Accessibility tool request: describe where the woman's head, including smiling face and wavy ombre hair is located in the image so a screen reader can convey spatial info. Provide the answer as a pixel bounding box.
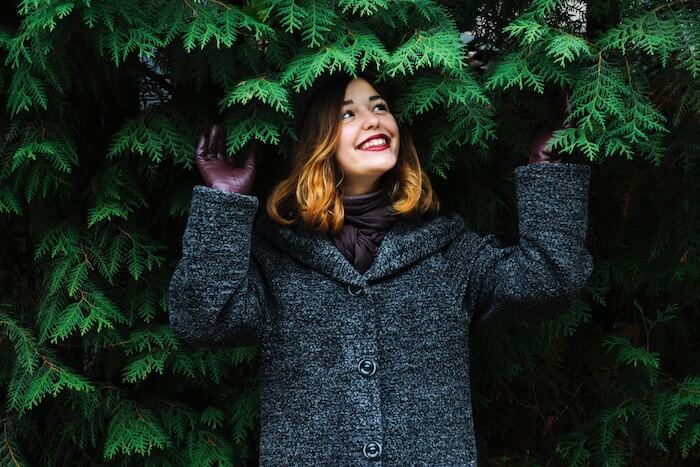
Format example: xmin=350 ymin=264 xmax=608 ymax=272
xmin=267 ymin=72 xmax=439 ymax=234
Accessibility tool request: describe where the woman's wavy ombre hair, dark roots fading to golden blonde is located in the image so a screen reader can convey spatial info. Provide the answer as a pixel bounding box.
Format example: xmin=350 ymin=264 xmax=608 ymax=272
xmin=267 ymin=73 xmax=440 ymax=234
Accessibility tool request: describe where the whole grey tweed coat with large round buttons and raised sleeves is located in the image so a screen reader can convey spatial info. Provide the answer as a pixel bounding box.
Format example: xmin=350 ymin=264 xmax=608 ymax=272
xmin=169 ymin=163 xmax=592 ymax=467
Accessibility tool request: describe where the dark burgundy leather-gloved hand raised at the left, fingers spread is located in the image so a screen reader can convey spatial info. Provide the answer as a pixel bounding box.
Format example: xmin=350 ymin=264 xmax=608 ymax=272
xmin=195 ymin=124 xmax=263 ymax=195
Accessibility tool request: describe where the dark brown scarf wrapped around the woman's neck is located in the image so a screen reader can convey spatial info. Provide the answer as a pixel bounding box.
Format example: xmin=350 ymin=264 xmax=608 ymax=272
xmin=331 ymin=188 xmax=397 ymax=274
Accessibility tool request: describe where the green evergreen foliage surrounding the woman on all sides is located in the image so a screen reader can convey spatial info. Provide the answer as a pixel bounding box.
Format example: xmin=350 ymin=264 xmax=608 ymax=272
xmin=0 ymin=0 xmax=700 ymax=466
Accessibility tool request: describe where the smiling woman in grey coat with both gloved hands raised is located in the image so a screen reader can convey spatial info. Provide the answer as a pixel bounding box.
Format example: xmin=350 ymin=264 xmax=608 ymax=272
xmin=170 ymin=71 xmax=592 ymax=466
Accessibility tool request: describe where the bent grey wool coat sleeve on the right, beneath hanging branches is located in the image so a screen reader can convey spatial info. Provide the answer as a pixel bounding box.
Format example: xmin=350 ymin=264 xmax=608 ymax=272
xmin=465 ymin=163 xmax=593 ymax=322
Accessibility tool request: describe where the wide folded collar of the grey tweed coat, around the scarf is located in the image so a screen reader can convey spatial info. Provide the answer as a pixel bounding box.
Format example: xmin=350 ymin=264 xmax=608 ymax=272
xmin=257 ymin=213 xmax=464 ymax=286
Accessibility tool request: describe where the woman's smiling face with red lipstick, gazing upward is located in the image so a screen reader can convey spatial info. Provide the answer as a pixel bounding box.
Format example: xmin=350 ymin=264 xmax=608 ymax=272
xmin=335 ymin=78 xmax=399 ymax=196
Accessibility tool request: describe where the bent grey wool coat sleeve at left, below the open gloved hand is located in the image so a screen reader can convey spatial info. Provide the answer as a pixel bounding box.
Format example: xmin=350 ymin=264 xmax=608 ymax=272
xmin=169 ymin=186 xmax=265 ymax=346
